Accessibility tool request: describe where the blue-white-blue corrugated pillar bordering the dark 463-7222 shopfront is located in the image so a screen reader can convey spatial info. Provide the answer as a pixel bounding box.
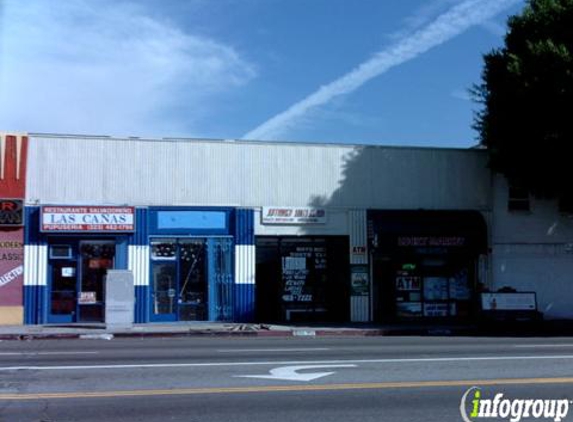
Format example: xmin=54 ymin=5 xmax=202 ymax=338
xmin=235 ymin=209 xmax=255 ymax=322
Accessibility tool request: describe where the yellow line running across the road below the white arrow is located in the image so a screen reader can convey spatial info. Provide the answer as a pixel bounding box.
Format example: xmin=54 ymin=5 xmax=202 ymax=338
xmin=0 ymin=377 xmax=573 ymax=400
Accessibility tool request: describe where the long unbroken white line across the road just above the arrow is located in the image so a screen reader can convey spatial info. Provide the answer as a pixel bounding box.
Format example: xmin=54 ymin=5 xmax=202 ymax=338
xmin=0 ymin=355 xmax=573 ymax=371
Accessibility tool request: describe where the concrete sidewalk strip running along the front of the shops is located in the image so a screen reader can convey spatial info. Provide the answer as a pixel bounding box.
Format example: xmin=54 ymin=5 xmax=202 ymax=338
xmin=0 ymin=321 xmax=573 ymax=340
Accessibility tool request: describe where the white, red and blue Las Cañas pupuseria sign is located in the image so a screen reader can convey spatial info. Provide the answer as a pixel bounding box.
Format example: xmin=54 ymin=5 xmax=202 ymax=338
xmin=41 ymin=206 xmax=135 ymax=233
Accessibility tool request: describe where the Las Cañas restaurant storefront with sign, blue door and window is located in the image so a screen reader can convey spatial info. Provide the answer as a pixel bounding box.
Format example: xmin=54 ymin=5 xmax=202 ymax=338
xmin=26 ymin=206 xmax=131 ymax=323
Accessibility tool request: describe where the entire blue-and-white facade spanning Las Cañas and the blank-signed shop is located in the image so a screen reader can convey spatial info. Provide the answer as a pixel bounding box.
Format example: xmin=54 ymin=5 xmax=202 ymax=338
xmin=24 ymin=205 xmax=255 ymax=324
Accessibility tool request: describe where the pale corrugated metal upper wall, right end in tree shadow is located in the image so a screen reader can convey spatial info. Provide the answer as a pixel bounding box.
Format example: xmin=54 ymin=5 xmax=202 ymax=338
xmin=26 ymin=136 xmax=490 ymax=209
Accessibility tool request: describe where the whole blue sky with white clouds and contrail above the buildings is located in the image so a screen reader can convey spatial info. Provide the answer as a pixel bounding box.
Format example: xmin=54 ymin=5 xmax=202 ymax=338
xmin=0 ymin=0 xmax=525 ymax=148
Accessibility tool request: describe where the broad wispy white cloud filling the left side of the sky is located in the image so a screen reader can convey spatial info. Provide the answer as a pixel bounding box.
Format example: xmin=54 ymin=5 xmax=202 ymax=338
xmin=0 ymin=0 xmax=256 ymax=136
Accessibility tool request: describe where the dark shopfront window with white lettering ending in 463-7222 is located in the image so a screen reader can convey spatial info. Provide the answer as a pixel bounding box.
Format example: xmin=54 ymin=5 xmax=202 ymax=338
xmin=256 ymin=236 xmax=350 ymax=321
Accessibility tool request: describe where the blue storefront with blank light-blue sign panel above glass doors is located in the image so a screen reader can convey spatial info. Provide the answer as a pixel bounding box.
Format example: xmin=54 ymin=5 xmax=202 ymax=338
xmin=149 ymin=208 xmax=235 ymax=321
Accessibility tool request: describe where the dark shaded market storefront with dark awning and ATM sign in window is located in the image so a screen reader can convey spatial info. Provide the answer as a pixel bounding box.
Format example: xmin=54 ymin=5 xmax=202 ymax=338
xmin=368 ymin=211 xmax=487 ymax=321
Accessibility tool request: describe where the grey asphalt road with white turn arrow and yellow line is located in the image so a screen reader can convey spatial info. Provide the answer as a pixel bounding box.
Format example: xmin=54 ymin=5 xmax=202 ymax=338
xmin=0 ymin=337 xmax=573 ymax=422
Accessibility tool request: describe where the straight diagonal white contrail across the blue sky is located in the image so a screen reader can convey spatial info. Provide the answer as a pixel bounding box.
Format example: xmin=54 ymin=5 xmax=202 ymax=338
xmin=242 ymin=0 xmax=523 ymax=139
